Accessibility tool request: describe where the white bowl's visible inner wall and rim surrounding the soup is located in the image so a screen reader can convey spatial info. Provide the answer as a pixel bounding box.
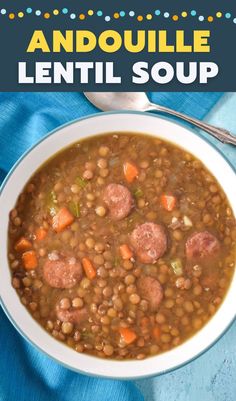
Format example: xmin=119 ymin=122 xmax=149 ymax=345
xmin=0 ymin=112 xmax=236 ymax=379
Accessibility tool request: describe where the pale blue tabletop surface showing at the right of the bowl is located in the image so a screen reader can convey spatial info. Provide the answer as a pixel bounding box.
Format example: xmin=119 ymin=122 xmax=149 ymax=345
xmin=136 ymin=94 xmax=236 ymax=401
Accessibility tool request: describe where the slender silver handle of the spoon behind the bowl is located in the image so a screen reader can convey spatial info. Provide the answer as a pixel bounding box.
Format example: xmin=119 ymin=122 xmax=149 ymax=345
xmin=148 ymin=103 xmax=236 ymax=146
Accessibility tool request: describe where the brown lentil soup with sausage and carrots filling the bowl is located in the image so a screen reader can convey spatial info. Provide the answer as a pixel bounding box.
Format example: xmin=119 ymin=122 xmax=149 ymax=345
xmin=9 ymin=133 xmax=236 ymax=359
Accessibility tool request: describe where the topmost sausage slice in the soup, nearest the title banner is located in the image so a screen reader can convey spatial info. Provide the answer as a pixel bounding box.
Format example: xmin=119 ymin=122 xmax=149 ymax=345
xmin=103 ymin=184 xmax=133 ymax=220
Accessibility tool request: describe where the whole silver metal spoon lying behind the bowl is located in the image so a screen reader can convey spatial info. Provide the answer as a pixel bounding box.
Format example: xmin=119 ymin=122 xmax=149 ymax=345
xmin=84 ymin=92 xmax=236 ymax=145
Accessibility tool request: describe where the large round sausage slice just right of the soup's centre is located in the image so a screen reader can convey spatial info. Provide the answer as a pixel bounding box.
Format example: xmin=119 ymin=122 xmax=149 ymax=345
xmin=130 ymin=223 xmax=167 ymax=263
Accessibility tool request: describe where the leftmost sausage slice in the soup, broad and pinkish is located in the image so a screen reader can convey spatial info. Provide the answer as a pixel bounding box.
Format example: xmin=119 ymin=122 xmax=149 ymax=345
xmin=43 ymin=257 xmax=83 ymax=288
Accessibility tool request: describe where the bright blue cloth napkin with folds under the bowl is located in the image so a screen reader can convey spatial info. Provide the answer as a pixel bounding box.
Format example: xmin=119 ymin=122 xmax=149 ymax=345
xmin=0 ymin=93 xmax=222 ymax=401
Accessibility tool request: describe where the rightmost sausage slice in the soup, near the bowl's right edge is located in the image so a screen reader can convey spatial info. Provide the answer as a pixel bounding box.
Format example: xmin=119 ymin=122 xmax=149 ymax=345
xmin=185 ymin=231 xmax=220 ymax=259
